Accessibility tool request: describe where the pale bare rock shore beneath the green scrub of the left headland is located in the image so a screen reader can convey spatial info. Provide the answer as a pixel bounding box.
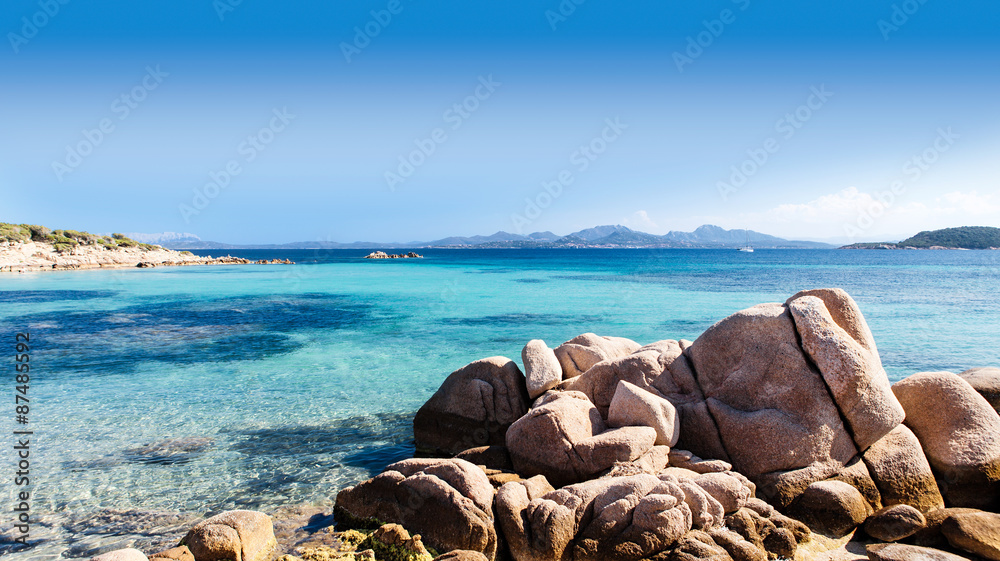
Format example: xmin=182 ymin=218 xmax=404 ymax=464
xmin=0 ymin=241 xmax=294 ymax=273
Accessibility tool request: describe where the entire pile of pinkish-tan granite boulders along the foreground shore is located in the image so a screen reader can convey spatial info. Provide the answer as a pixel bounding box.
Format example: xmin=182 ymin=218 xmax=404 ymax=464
xmin=78 ymin=289 xmax=1000 ymax=561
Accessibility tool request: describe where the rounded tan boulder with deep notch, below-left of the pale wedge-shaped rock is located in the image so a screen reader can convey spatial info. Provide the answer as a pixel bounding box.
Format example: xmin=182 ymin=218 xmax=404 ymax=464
xmin=507 ymin=391 xmax=656 ymax=486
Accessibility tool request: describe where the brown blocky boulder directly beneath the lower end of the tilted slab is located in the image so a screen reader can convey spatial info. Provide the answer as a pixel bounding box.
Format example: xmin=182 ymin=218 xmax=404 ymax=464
xmin=861 ymin=425 xmax=944 ymax=513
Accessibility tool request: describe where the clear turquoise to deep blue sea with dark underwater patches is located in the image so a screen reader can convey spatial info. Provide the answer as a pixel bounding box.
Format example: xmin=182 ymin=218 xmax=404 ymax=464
xmin=0 ymin=249 xmax=1000 ymax=559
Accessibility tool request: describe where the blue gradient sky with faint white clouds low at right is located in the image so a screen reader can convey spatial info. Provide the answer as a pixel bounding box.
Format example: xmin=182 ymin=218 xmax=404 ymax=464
xmin=0 ymin=0 xmax=1000 ymax=243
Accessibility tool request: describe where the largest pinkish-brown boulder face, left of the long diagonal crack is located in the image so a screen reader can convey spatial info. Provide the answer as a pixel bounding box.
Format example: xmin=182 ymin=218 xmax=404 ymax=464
xmin=682 ymin=304 xmax=858 ymax=487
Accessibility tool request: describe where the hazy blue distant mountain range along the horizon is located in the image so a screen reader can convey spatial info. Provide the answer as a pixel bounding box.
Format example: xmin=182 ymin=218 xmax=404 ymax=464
xmin=152 ymin=224 xmax=835 ymax=249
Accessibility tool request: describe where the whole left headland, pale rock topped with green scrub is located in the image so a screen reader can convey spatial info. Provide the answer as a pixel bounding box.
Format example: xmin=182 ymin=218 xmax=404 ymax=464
xmin=0 ymin=222 xmax=292 ymax=273
